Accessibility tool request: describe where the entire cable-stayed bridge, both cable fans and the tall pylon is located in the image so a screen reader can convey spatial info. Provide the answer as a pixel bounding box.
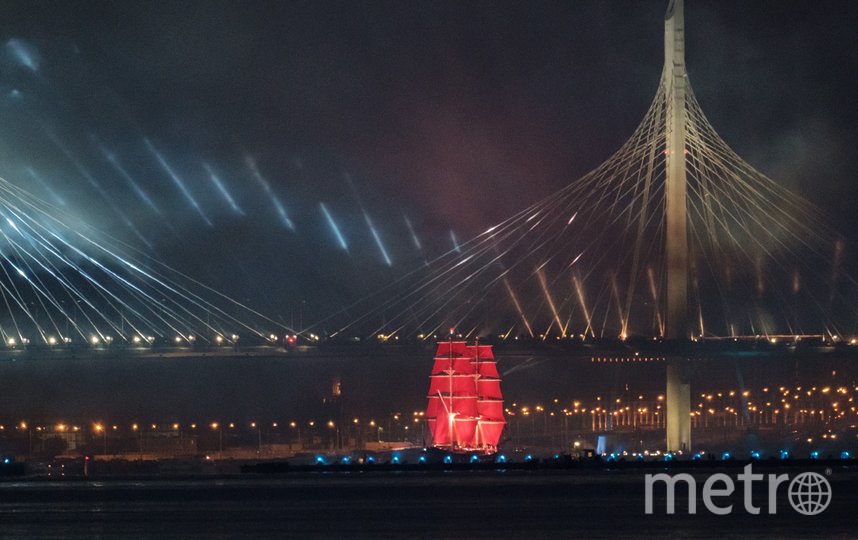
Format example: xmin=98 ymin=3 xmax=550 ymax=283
xmin=0 ymin=0 xmax=858 ymax=449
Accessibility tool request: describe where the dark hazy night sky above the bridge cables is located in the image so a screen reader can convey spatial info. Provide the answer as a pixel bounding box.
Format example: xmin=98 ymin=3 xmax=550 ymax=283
xmin=0 ymin=0 xmax=858 ymax=324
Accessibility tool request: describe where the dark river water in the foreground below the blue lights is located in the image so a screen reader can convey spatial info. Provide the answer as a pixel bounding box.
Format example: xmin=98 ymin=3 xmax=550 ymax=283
xmin=0 ymin=470 xmax=858 ymax=538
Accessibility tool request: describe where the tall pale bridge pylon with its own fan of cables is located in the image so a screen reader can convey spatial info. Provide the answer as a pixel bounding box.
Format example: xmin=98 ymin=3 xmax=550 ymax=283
xmin=316 ymin=0 xmax=858 ymax=451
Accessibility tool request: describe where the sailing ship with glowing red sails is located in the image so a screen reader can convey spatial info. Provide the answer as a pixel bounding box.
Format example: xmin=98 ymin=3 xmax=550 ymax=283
xmin=426 ymin=339 xmax=506 ymax=454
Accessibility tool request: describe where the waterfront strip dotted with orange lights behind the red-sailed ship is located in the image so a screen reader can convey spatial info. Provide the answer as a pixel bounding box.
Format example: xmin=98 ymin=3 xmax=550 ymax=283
xmin=0 ymin=378 xmax=858 ymax=460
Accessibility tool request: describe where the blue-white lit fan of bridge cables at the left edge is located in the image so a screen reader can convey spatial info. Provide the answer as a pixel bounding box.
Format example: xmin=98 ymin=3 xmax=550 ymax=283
xmin=0 ymin=173 xmax=294 ymax=348
